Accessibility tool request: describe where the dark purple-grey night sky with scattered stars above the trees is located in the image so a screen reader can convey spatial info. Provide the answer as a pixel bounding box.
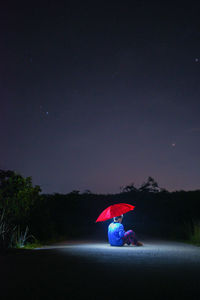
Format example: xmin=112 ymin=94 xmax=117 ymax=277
xmin=0 ymin=0 xmax=200 ymax=193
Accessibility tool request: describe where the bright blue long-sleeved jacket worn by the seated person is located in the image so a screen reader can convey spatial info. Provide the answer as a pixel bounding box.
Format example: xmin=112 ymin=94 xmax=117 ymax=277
xmin=108 ymin=222 xmax=125 ymax=246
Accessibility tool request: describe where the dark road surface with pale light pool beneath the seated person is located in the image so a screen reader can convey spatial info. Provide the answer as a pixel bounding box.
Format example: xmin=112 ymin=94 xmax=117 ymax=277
xmin=0 ymin=240 xmax=200 ymax=299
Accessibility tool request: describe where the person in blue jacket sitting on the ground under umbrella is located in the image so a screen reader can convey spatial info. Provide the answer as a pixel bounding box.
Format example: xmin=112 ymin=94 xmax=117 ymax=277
xmin=108 ymin=215 xmax=143 ymax=246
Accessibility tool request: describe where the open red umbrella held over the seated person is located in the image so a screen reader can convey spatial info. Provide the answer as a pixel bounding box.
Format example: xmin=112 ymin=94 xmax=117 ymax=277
xmin=96 ymin=203 xmax=135 ymax=223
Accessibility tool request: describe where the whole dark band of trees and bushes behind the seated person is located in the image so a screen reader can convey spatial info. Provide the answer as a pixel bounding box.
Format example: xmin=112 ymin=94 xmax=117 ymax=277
xmin=0 ymin=170 xmax=200 ymax=247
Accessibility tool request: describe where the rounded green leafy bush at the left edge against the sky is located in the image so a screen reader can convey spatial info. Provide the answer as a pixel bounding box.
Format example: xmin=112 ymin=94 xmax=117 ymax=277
xmin=0 ymin=170 xmax=41 ymax=222
